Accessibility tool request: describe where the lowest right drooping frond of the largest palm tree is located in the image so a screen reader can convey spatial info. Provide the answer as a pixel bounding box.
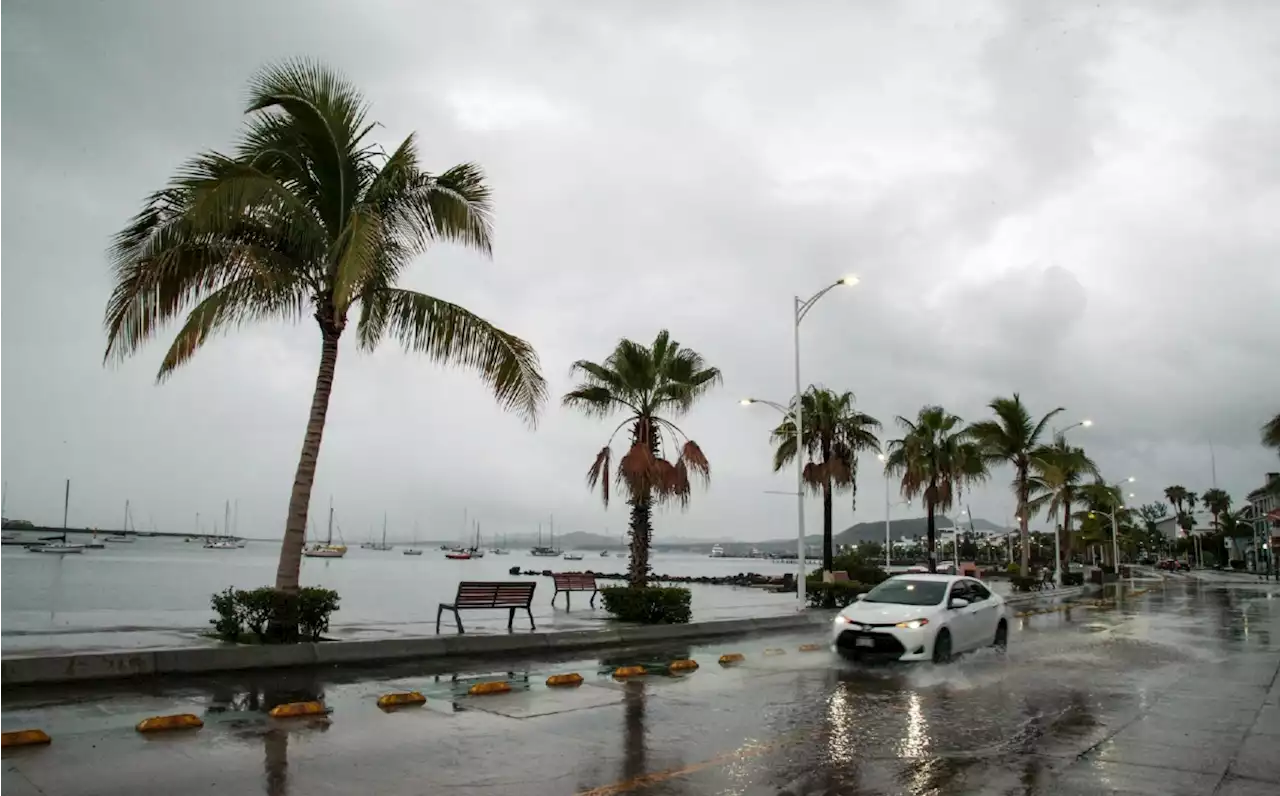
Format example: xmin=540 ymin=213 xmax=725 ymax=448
xmin=378 ymin=289 xmax=547 ymax=425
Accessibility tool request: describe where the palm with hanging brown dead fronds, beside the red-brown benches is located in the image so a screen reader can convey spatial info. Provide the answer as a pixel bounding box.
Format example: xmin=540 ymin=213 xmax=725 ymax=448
xmin=563 ymin=329 xmax=721 ymax=586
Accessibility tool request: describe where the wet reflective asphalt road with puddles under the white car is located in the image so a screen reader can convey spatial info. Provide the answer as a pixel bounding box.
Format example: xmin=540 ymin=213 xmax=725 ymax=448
xmin=0 ymin=580 xmax=1280 ymax=796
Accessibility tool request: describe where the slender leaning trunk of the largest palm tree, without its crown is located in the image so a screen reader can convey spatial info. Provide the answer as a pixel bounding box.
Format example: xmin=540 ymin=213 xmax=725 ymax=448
xmin=268 ymin=320 xmax=342 ymax=642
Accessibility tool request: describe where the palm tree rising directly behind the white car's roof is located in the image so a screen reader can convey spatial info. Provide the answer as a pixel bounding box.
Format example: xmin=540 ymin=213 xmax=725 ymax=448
xmin=884 ymin=406 xmax=987 ymax=572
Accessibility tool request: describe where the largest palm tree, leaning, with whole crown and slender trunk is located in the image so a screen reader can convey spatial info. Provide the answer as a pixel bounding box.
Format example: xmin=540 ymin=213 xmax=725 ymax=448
xmin=99 ymin=61 xmax=547 ymax=635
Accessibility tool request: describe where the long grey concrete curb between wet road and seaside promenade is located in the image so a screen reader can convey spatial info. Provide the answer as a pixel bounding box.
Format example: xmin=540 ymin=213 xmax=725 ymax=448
xmin=0 ymin=610 xmax=832 ymax=685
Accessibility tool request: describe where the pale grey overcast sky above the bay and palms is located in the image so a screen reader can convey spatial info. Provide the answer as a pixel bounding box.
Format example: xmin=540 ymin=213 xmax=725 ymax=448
xmin=0 ymin=0 xmax=1280 ymax=540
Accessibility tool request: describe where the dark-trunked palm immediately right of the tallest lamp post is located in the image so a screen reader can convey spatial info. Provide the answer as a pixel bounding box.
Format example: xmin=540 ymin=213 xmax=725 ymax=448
xmin=772 ymin=385 xmax=881 ymax=572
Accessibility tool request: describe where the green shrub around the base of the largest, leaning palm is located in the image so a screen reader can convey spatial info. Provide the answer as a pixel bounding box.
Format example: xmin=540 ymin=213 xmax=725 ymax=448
xmin=209 ymin=586 xmax=338 ymax=644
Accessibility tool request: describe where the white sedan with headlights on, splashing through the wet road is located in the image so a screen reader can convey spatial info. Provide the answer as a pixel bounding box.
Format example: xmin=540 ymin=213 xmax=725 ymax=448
xmin=831 ymin=575 xmax=1009 ymax=663
